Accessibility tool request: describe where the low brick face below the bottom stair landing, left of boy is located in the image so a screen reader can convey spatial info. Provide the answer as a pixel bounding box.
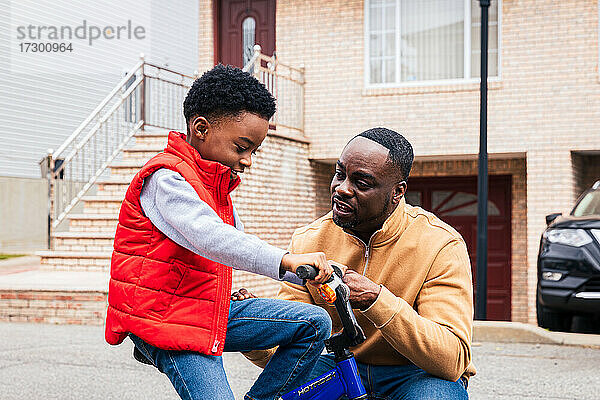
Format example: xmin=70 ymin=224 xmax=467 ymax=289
xmin=0 ymin=290 xmax=107 ymax=325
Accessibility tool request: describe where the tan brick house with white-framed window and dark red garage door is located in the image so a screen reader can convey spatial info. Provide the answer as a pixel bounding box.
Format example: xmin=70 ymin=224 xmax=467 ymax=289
xmin=199 ymin=0 xmax=600 ymax=322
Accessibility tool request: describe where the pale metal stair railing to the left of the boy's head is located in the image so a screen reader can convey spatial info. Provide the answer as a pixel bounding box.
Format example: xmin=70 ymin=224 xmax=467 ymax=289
xmin=40 ymin=55 xmax=195 ymax=248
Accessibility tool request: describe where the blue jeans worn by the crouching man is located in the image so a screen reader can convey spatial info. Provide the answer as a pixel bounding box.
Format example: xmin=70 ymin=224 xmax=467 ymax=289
xmin=312 ymin=354 xmax=469 ymax=400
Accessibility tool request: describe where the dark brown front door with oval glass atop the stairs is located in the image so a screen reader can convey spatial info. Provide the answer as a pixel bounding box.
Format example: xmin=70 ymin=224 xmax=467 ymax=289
xmin=215 ymin=0 xmax=275 ymax=67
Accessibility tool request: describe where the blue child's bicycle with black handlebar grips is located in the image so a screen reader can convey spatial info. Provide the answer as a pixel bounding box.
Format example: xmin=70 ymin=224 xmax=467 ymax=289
xmin=279 ymin=265 xmax=367 ymax=400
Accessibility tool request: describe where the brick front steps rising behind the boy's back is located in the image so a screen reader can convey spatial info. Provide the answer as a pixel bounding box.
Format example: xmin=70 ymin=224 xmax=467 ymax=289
xmin=0 ymin=130 xmax=167 ymax=325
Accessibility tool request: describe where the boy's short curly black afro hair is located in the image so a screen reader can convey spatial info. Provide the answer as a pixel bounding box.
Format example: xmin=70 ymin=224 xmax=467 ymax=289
xmin=183 ymin=64 xmax=275 ymax=122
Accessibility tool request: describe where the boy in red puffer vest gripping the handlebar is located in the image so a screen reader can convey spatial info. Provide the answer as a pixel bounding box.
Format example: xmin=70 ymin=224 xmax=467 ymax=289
xmin=106 ymin=65 xmax=333 ymax=400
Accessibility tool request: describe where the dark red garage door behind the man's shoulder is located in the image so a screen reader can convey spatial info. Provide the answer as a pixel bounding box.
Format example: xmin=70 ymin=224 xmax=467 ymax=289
xmin=406 ymin=175 xmax=511 ymax=321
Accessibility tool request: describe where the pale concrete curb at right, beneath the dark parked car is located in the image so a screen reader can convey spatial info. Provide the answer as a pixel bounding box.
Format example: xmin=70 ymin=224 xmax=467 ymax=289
xmin=473 ymin=321 xmax=600 ymax=348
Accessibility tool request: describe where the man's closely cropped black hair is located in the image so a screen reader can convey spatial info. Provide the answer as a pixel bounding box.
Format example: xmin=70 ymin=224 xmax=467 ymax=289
xmin=355 ymin=128 xmax=414 ymax=180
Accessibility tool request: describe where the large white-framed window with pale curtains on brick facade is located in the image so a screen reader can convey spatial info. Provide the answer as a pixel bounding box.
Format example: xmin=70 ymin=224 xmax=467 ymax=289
xmin=365 ymin=0 xmax=500 ymax=86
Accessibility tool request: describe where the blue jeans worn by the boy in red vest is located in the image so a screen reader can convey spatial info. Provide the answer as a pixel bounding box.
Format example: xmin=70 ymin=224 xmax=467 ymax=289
xmin=130 ymin=299 xmax=331 ymax=400
